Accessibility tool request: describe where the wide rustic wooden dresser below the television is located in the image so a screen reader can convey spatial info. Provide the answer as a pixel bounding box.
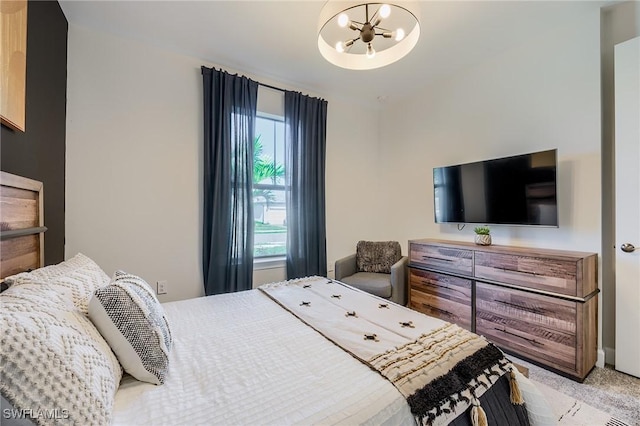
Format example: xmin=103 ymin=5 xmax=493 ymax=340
xmin=409 ymin=239 xmax=599 ymax=381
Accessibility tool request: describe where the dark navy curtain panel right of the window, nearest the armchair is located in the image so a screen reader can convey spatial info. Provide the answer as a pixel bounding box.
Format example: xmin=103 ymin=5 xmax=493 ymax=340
xmin=284 ymin=91 xmax=327 ymax=279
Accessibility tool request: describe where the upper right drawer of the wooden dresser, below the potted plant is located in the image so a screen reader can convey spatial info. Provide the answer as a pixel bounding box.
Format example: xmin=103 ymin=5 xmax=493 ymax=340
xmin=475 ymin=251 xmax=583 ymax=296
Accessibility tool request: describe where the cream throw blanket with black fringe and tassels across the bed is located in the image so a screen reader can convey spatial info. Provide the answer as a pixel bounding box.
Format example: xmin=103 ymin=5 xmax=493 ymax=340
xmin=260 ymin=277 xmax=522 ymax=425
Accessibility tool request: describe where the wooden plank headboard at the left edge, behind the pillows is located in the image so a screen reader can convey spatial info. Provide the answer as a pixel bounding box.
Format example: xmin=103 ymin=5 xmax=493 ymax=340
xmin=0 ymin=172 xmax=47 ymax=279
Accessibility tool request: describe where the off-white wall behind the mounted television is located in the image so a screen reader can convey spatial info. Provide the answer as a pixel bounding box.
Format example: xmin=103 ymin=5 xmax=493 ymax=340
xmin=381 ymin=11 xmax=601 ymax=354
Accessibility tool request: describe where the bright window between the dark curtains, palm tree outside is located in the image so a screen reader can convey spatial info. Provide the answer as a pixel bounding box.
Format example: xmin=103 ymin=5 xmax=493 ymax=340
xmin=253 ymin=115 xmax=287 ymax=258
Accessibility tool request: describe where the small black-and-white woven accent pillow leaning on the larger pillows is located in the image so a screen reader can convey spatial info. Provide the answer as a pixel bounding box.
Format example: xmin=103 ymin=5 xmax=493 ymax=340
xmin=89 ymin=271 xmax=171 ymax=385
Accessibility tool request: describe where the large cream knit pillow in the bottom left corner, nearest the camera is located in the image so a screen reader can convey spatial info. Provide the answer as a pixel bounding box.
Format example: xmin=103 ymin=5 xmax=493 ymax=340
xmin=0 ymin=282 xmax=122 ymax=425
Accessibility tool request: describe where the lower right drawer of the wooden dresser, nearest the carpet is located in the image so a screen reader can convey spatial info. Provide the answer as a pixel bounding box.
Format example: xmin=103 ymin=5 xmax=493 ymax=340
xmin=476 ymin=282 xmax=577 ymax=373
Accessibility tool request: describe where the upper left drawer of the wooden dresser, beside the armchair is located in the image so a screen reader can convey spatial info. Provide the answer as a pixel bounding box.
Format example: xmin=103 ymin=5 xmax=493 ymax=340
xmin=409 ymin=243 xmax=473 ymax=275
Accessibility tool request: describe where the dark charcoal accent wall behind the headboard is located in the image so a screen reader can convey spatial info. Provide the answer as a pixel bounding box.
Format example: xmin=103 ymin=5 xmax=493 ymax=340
xmin=0 ymin=1 xmax=68 ymax=265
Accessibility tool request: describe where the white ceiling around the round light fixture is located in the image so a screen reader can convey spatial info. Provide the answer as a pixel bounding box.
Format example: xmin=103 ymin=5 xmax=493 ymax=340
xmin=60 ymin=0 xmax=611 ymax=103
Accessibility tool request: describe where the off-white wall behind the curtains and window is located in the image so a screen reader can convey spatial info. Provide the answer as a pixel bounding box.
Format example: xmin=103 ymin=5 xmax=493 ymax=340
xmin=65 ymin=25 xmax=378 ymax=301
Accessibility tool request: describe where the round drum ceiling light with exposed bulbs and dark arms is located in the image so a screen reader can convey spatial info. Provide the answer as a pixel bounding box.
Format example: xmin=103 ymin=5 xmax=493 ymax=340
xmin=318 ymin=0 xmax=420 ymax=70
